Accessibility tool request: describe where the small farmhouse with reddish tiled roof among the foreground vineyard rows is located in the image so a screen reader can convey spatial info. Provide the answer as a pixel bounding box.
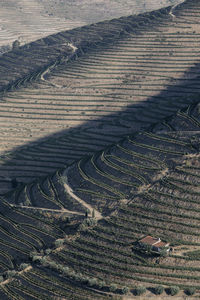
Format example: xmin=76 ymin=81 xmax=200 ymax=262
xmin=137 ymin=235 xmax=170 ymax=253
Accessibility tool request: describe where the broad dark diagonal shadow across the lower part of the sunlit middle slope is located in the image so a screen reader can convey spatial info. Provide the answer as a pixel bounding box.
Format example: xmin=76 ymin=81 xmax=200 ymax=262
xmin=0 ymin=55 xmax=200 ymax=195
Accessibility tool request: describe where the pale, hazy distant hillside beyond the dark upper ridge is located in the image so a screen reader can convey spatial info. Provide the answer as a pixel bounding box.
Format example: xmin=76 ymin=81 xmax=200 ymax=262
xmin=0 ymin=0 xmax=177 ymax=54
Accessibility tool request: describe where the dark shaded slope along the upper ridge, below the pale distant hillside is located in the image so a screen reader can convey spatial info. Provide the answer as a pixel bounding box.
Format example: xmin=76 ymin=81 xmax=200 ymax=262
xmin=0 ymin=3 xmax=171 ymax=94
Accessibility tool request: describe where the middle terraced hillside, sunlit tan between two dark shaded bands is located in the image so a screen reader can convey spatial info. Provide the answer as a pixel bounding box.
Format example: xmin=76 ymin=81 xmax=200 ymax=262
xmin=0 ymin=1 xmax=199 ymax=193
